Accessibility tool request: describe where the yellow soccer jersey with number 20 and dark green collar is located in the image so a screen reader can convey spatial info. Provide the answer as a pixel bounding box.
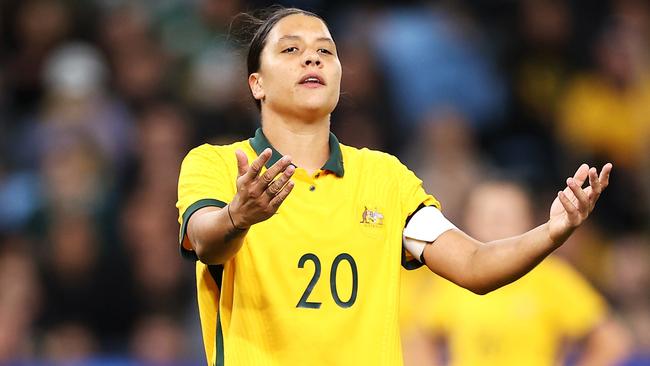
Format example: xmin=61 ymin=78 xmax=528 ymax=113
xmin=177 ymin=129 xmax=439 ymax=366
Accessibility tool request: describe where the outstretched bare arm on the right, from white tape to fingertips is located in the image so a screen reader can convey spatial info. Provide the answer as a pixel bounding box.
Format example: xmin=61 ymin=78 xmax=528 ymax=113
xmin=423 ymin=163 xmax=612 ymax=294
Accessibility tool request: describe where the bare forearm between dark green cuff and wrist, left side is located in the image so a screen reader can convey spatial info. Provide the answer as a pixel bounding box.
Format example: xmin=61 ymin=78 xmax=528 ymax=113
xmin=187 ymin=207 xmax=248 ymax=264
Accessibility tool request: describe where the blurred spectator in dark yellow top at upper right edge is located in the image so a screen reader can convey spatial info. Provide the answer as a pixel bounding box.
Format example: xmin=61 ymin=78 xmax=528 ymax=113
xmin=558 ymin=19 xmax=650 ymax=169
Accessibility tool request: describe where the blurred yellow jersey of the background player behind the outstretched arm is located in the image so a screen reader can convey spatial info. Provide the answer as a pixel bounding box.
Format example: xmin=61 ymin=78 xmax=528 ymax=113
xmin=404 ymin=256 xmax=606 ymax=366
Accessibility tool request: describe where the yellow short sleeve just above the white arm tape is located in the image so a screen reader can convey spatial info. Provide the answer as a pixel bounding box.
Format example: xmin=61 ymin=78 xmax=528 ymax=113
xmin=394 ymin=158 xmax=441 ymax=270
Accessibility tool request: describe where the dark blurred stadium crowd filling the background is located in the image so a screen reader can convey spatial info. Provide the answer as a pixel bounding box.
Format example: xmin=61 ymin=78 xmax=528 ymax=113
xmin=0 ymin=0 xmax=650 ymax=364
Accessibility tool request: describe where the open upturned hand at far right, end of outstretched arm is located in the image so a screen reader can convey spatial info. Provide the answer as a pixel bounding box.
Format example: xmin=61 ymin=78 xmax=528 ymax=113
xmin=548 ymin=163 xmax=612 ymax=244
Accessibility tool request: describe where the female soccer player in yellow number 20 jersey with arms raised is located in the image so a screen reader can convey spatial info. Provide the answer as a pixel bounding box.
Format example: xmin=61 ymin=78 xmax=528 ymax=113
xmin=177 ymin=8 xmax=612 ymax=365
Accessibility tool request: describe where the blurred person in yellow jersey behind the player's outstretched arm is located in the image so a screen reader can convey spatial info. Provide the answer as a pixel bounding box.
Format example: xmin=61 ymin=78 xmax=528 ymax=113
xmin=404 ymin=181 xmax=629 ymax=365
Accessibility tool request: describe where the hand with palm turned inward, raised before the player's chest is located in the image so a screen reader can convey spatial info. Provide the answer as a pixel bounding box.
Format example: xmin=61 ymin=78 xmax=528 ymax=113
xmin=228 ymin=148 xmax=296 ymax=229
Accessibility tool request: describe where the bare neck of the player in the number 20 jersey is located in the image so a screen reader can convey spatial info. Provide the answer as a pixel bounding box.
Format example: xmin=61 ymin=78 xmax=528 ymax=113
xmin=262 ymin=110 xmax=330 ymax=174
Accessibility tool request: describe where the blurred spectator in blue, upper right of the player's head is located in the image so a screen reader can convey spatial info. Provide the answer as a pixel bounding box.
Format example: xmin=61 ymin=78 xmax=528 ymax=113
xmin=371 ymin=2 xmax=504 ymax=139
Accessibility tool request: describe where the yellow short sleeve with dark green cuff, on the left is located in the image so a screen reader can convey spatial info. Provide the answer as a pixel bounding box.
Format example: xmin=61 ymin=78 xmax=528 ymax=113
xmin=176 ymin=144 xmax=236 ymax=260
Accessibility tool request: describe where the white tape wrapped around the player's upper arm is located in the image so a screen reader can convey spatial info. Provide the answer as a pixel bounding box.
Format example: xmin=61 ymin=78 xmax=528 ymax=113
xmin=402 ymin=206 xmax=456 ymax=261
